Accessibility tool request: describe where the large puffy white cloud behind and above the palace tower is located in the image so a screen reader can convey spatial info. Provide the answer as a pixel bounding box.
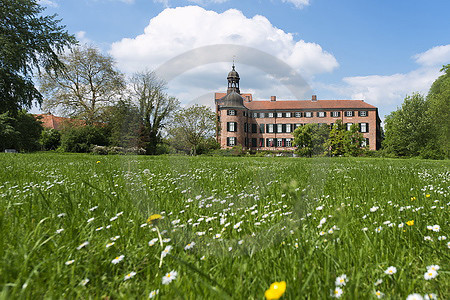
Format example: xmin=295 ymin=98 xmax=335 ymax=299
xmin=110 ymin=6 xmax=338 ymax=102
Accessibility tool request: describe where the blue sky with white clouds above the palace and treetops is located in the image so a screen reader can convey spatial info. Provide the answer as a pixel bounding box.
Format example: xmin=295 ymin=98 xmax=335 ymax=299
xmin=40 ymin=0 xmax=450 ymax=118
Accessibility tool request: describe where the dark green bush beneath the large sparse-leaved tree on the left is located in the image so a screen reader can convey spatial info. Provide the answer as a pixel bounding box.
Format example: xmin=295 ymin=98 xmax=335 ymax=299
xmin=61 ymin=125 xmax=109 ymax=153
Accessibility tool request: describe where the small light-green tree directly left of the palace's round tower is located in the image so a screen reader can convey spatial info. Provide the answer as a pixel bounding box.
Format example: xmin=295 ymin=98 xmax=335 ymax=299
xmin=169 ymin=105 xmax=216 ymax=155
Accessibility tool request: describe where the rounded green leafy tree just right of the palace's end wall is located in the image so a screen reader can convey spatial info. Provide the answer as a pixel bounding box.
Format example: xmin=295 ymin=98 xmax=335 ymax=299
xmin=383 ymin=93 xmax=435 ymax=157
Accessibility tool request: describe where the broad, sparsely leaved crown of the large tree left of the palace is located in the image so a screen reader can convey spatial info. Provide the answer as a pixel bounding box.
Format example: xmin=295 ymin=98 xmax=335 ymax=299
xmin=41 ymin=46 xmax=125 ymax=124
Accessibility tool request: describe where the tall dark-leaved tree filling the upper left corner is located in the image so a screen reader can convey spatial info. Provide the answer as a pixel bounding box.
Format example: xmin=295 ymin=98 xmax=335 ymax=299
xmin=0 ymin=0 xmax=76 ymax=115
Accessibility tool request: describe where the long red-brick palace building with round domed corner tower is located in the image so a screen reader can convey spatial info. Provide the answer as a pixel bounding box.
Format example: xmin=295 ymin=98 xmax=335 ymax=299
xmin=215 ymin=64 xmax=381 ymax=150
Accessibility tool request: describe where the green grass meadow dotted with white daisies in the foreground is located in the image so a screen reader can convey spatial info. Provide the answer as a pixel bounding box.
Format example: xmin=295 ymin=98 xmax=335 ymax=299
xmin=0 ymin=153 xmax=450 ymax=299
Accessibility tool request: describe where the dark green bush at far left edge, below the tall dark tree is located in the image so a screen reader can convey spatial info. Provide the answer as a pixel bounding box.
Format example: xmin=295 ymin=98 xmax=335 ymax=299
xmin=0 ymin=110 xmax=43 ymax=152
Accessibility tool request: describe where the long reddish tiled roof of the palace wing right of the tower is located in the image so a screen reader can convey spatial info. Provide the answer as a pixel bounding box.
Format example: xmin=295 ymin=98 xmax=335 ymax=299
xmin=245 ymin=100 xmax=376 ymax=110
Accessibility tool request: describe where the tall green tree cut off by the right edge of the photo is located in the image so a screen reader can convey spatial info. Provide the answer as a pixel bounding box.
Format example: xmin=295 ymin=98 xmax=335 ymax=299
xmin=427 ymin=64 xmax=450 ymax=158
